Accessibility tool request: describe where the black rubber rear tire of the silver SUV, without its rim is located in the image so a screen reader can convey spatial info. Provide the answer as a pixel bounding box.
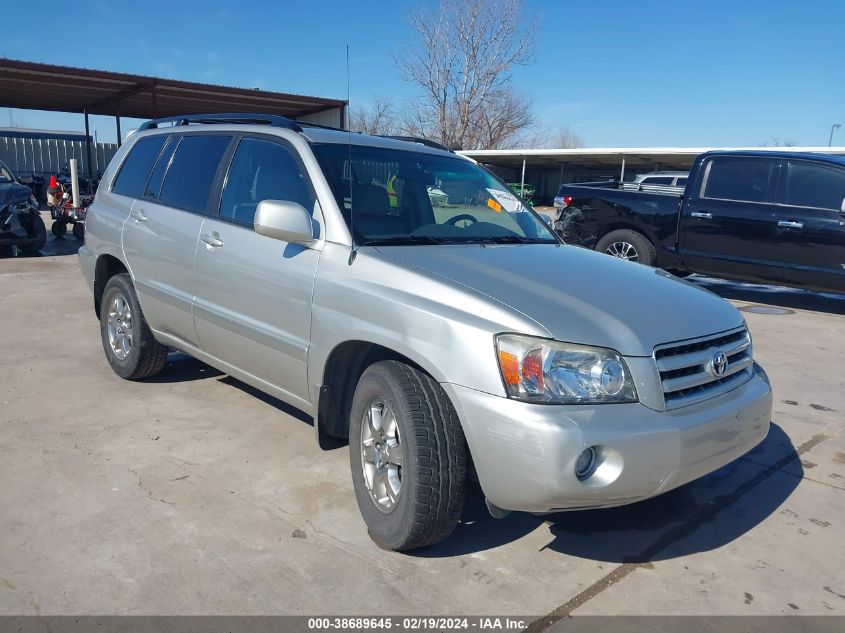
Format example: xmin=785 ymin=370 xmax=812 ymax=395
xmin=100 ymin=273 xmax=167 ymax=380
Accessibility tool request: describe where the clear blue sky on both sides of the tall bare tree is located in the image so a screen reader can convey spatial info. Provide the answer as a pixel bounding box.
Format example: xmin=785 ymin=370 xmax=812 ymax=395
xmin=0 ymin=0 xmax=845 ymax=147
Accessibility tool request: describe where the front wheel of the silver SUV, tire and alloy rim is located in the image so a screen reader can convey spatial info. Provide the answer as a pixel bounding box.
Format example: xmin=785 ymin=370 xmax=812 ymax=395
xmin=349 ymin=360 xmax=467 ymax=550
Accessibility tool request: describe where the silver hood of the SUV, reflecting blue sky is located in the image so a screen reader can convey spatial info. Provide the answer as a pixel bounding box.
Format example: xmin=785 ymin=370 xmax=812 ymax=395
xmin=378 ymin=244 xmax=743 ymax=356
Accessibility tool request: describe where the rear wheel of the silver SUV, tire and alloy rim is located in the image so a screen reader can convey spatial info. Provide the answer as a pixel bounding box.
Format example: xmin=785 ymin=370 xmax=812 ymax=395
xmin=100 ymin=273 xmax=167 ymax=380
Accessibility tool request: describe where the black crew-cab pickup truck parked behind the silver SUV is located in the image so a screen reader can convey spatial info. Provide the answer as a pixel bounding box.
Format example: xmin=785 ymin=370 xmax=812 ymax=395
xmin=555 ymin=151 xmax=845 ymax=293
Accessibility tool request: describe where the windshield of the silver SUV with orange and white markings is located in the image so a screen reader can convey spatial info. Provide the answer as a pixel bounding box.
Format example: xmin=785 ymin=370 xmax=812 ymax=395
xmin=313 ymin=143 xmax=557 ymax=245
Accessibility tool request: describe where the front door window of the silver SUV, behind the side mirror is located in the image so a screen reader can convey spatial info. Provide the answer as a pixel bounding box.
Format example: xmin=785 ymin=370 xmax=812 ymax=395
xmin=220 ymin=138 xmax=314 ymax=225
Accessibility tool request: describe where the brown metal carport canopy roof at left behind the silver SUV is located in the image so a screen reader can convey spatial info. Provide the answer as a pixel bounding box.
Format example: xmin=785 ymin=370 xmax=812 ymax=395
xmin=0 ymin=58 xmax=346 ymax=122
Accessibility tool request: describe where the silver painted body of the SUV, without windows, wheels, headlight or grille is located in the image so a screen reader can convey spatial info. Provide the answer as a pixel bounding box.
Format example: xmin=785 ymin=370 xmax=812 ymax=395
xmin=80 ymin=125 xmax=771 ymax=512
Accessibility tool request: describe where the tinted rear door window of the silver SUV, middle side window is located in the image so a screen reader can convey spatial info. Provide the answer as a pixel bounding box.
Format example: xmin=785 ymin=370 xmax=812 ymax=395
xmin=159 ymin=135 xmax=231 ymax=213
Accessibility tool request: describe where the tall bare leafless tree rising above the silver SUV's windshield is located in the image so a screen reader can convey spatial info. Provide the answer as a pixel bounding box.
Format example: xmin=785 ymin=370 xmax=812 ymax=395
xmin=395 ymin=0 xmax=535 ymax=149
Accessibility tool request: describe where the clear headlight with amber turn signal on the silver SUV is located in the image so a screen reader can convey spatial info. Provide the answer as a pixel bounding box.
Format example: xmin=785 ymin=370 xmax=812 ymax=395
xmin=496 ymin=334 xmax=637 ymax=404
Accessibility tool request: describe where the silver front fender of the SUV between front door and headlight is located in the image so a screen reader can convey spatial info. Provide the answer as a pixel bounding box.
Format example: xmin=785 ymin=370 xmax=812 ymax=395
xmin=308 ymin=243 xmax=549 ymax=402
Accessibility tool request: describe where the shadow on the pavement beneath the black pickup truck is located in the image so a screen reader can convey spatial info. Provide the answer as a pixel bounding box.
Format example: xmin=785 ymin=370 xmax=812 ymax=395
xmin=686 ymin=275 xmax=845 ymax=314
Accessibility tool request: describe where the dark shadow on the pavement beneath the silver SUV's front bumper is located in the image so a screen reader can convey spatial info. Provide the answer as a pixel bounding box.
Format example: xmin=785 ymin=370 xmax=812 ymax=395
xmin=411 ymin=424 xmax=803 ymax=563
